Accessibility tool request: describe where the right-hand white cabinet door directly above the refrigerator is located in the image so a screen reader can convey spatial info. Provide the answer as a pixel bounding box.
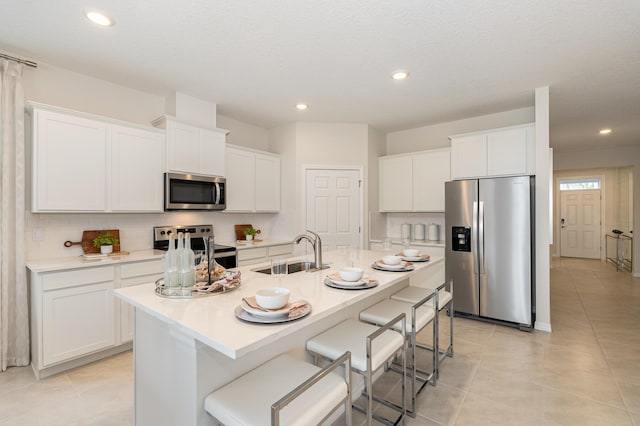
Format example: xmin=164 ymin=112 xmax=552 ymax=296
xmin=487 ymin=127 xmax=527 ymax=176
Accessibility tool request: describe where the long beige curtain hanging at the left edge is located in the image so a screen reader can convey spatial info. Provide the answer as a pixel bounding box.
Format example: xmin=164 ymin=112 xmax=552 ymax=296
xmin=0 ymin=59 xmax=29 ymax=371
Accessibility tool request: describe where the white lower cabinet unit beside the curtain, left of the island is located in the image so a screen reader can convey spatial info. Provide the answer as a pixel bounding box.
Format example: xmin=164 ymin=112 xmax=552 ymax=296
xmin=29 ymin=259 xmax=163 ymax=377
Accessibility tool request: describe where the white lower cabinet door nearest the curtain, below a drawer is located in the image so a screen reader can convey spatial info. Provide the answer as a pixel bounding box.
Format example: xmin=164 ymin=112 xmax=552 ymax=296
xmin=42 ymin=281 xmax=115 ymax=366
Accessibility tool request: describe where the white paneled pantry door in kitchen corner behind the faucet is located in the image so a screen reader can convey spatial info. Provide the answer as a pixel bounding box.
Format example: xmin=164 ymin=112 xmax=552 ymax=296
xmin=305 ymin=169 xmax=362 ymax=250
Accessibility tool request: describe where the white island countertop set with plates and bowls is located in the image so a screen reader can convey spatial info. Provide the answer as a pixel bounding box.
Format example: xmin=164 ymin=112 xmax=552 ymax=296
xmin=115 ymin=250 xmax=444 ymax=359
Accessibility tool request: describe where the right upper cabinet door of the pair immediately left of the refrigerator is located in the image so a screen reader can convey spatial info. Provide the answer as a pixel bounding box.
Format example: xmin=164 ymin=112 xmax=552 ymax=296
xmin=413 ymin=150 xmax=451 ymax=212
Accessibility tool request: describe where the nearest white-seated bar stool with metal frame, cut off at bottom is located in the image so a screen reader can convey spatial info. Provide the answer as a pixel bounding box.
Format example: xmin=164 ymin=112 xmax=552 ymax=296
xmin=204 ymin=352 xmax=351 ymax=426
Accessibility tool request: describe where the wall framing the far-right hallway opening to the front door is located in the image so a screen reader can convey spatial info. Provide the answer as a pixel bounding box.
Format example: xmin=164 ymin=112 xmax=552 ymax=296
xmin=553 ymin=145 xmax=640 ymax=277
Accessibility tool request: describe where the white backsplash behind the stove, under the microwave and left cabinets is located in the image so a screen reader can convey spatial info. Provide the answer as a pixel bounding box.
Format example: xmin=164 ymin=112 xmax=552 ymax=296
xmin=25 ymin=212 xmax=293 ymax=260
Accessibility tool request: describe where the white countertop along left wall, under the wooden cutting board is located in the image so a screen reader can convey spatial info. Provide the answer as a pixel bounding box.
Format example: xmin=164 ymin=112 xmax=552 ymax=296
xmin=26 ymin=250 xmax=164 ymax=272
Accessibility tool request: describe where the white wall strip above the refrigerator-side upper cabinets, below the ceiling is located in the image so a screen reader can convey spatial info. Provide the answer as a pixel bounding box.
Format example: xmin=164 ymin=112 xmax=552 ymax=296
xmin=387 ymin=107 xmax=535 ymax=155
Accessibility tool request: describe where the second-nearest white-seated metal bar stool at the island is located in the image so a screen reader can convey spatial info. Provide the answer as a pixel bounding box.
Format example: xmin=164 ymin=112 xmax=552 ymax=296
xmin=307 ymin=314 xmax=406 ymax=425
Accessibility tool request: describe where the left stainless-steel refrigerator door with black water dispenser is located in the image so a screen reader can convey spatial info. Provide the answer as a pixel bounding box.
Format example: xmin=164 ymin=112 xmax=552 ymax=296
xmin=445 ymin=180 xmax=480 ymax=315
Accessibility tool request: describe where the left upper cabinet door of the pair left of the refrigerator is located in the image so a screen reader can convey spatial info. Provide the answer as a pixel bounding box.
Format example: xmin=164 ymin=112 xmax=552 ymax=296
xmin=379 ymin=155 xmax=413 ymax=212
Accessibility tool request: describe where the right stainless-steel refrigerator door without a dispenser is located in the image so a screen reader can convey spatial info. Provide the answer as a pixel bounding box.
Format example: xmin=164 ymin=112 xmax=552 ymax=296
xmin=478 ymin=176 xmax=532 ymax=325
